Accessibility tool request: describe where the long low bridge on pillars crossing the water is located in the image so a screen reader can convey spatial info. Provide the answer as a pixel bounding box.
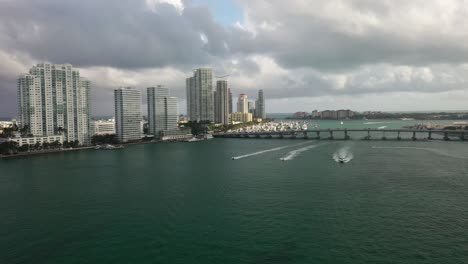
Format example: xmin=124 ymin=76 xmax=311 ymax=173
xmin=213 ymin=129 xmax=468 ymax=141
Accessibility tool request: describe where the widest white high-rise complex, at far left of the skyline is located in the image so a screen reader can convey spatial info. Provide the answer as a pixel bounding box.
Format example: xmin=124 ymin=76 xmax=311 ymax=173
xmin=18 ymin=63 xmax=92 ymax=145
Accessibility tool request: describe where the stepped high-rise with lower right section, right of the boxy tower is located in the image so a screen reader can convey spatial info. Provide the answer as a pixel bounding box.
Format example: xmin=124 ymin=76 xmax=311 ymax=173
xmin=147 ymin=85 xmax=179 ymax=137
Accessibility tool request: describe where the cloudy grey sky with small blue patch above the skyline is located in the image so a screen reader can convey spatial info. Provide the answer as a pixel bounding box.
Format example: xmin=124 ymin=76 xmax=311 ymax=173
xmin=0 ymin=0 xmax=468 ymax=116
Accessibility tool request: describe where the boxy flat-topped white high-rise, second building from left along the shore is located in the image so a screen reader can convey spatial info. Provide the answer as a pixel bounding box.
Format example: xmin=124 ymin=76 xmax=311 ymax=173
xmin=114 ymin=87 xmax=142 ymax=142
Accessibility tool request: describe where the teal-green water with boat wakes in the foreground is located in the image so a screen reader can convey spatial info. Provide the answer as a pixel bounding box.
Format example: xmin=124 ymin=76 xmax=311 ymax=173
xmin=0 ymin=121 xmax=468 ymax=264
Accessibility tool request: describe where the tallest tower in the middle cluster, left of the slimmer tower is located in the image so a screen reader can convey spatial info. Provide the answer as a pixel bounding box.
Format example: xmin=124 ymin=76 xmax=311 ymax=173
xmin=186 ymin=68 xmax=214 ymax=122
